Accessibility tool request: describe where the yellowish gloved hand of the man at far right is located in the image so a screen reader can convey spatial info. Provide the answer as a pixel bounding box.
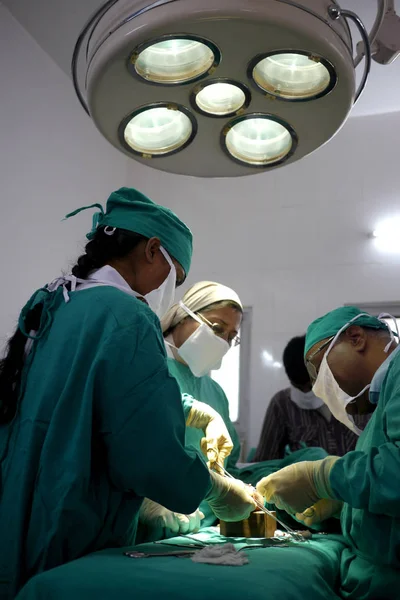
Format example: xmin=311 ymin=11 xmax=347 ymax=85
xmin=257 ymin=456 xmax=339 ymax=514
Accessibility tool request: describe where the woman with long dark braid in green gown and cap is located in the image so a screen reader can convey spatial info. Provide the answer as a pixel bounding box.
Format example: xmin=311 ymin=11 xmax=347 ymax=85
xmin=0 ymin=188 xmax=255 ymax=600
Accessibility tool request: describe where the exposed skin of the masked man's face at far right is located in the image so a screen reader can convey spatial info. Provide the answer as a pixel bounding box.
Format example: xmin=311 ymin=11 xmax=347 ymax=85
xmin=306 ymin=325 xmax=397 ymax=414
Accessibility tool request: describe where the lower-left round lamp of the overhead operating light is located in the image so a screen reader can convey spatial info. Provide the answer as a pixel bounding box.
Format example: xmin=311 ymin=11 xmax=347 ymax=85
xmin=120 ymin=105 xmax=196 ymax=158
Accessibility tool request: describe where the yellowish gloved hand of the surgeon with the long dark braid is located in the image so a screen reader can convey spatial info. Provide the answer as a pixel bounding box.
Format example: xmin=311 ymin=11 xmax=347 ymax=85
xmin=206 ymin=472 xmax=257 ymax=521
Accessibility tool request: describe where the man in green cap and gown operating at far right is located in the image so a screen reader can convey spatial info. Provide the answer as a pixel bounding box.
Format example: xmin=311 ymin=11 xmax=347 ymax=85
xmin=258 ymin=307 xmax=400 ymax=600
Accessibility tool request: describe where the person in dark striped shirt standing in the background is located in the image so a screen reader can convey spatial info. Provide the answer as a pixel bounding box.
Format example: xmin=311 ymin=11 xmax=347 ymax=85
xmin=254 ymin=335 xmax=369 ymax=462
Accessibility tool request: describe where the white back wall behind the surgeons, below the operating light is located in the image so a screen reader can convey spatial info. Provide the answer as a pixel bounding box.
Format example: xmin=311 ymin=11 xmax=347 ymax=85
xmin=126 ymin=113 xmax=400 ymax=444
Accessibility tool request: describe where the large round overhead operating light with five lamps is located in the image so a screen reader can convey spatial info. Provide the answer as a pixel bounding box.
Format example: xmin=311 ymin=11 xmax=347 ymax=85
xmin=72 ymin=0 xmax=400 ymax=177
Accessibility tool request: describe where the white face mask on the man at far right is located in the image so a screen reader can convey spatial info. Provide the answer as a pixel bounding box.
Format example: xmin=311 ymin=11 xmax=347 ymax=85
xmin=313 ymin=314 xmax=394 ymax=435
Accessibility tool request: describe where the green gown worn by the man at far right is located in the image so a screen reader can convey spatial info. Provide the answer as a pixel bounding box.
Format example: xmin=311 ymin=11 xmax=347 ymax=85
xmin=330 ymin=352 xmax=400 ymax=600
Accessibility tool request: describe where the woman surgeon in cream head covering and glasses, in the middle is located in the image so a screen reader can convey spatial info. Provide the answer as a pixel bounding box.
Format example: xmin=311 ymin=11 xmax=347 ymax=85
xmin=139 ymin=281 xmax=243 ymax=541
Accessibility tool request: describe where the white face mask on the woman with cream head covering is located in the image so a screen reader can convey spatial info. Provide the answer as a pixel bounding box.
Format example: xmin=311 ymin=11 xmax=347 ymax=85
xmin=170 ymin=302 xmax=230 ymax=377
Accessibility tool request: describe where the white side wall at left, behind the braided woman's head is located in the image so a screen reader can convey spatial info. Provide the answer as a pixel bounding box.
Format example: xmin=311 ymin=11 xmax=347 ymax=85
xmin=0 ymin=4 xmax=127 ymax=338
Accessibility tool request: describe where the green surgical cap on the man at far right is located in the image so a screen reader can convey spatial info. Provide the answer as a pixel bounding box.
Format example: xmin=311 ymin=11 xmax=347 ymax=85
xmin=304 ymin=306 xmax=389 ymax=356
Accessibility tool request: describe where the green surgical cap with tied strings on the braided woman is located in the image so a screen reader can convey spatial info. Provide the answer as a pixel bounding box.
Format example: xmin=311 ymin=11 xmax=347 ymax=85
xmin=65 ymin=188 xmax=193 ymax=275
